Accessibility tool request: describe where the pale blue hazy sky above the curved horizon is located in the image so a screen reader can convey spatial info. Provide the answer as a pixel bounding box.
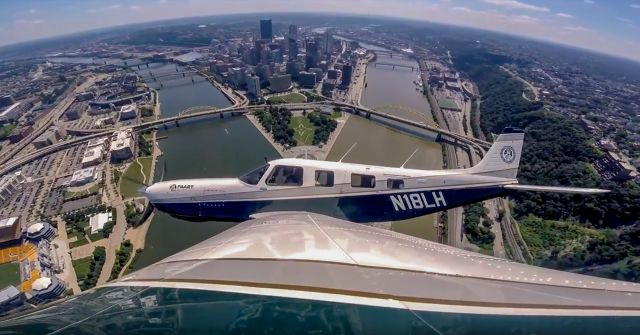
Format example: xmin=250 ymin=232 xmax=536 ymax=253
xmin=0 ymin=0 xmax=640 ymax=60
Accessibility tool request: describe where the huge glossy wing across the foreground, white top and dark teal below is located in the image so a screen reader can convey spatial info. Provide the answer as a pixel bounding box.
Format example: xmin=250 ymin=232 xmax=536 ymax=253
xmin=0 ymin=212 xmax=640 ymax=335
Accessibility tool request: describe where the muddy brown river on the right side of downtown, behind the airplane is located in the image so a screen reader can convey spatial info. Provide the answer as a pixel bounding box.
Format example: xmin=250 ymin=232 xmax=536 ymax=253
xmin=327 ymin=42 xmax=442 ymax=241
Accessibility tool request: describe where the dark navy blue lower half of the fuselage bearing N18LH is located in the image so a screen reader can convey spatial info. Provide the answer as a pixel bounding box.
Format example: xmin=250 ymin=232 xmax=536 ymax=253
xmin=154 ymin=186 xmax=507 ymax=222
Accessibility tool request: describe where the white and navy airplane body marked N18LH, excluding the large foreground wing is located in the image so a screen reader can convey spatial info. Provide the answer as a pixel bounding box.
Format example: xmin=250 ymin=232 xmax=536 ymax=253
xmin=141 ymin=128 xmax=608 ymax=223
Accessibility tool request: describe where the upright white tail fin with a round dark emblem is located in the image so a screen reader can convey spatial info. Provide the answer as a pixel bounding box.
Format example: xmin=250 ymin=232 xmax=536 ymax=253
xmin=468 ymin=127 xmax=524 ymax=179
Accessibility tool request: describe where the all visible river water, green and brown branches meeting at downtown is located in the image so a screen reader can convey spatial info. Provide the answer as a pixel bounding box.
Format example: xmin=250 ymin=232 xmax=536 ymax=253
xmin=134 ymin=46 xmax=442 ymax=268
